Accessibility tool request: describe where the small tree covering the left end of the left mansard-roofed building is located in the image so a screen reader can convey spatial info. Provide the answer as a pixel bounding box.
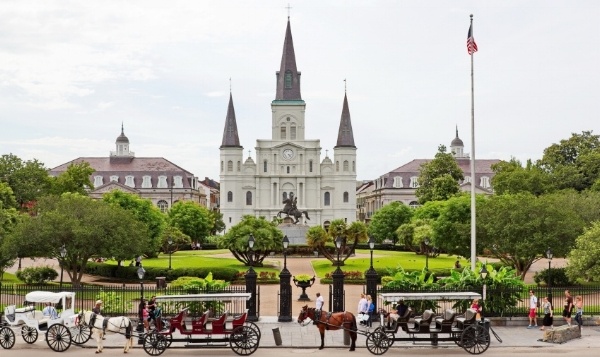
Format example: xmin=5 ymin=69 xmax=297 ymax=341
xmin=50 ymin=162 xmax=96 ymax=196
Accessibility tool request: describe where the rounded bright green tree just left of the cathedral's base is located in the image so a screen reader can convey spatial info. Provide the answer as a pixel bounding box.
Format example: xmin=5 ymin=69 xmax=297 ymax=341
xmin=168 ymin=201 xmax=215 ymax=243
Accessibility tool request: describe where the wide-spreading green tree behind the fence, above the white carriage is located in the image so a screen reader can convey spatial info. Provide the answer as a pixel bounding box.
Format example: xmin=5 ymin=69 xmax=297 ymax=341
xmin=7 ymin=193 xmax=148 ymax=286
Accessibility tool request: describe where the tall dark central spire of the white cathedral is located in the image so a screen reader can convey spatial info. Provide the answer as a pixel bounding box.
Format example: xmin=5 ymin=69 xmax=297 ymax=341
xmin=275 ymin=17 xmax=302 ymax=100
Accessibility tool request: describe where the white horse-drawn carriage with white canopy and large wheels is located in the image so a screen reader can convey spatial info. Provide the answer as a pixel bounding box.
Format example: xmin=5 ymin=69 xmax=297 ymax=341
xmin=0 ymin=291 xmax=91 ymax=352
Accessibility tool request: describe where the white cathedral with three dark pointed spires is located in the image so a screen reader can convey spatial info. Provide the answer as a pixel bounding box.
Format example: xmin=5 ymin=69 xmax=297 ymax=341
xmin=220 ymin=18 xmax=356 ymax=228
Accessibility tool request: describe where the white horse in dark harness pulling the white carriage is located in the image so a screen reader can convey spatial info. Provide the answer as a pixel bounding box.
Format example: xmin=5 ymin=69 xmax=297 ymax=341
xmin=78 ymin=311 xmax=133 ymax=353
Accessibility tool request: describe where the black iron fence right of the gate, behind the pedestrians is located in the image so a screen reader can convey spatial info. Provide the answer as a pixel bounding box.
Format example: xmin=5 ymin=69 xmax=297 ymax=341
xmin=375 ymin=285 xmax=600 ymax=317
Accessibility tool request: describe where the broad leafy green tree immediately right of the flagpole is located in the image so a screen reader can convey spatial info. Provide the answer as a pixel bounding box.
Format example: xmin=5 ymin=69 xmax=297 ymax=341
xmin=477 ymin=193 xmax=585 ymax=278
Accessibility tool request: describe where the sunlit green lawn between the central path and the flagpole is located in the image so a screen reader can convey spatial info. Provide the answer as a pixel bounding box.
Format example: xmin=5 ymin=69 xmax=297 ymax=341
xmin=312 ymin=250 xmax=468 ymax=278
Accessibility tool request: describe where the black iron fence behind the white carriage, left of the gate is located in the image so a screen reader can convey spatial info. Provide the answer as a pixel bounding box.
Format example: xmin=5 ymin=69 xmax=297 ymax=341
xmin=0 ymin=284 xmax=260 ymax=317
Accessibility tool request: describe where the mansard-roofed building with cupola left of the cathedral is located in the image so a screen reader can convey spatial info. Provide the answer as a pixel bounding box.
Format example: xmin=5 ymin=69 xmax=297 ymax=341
xmin=49 ymin=126 xmax=207 ymax=212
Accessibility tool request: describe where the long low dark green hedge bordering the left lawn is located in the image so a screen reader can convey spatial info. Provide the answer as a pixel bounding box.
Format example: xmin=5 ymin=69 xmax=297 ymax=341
xmin=86 ymin=262 xmax=238 ymax=281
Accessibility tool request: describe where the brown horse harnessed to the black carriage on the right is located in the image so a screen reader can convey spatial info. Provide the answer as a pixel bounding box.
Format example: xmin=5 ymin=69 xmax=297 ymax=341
xmin=298 ymin=305 xmax=358 ymax=351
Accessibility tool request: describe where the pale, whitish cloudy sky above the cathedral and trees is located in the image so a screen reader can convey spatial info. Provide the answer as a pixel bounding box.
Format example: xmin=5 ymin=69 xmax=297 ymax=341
xmin=0 ymin=0 xmax=600 ymax=180
